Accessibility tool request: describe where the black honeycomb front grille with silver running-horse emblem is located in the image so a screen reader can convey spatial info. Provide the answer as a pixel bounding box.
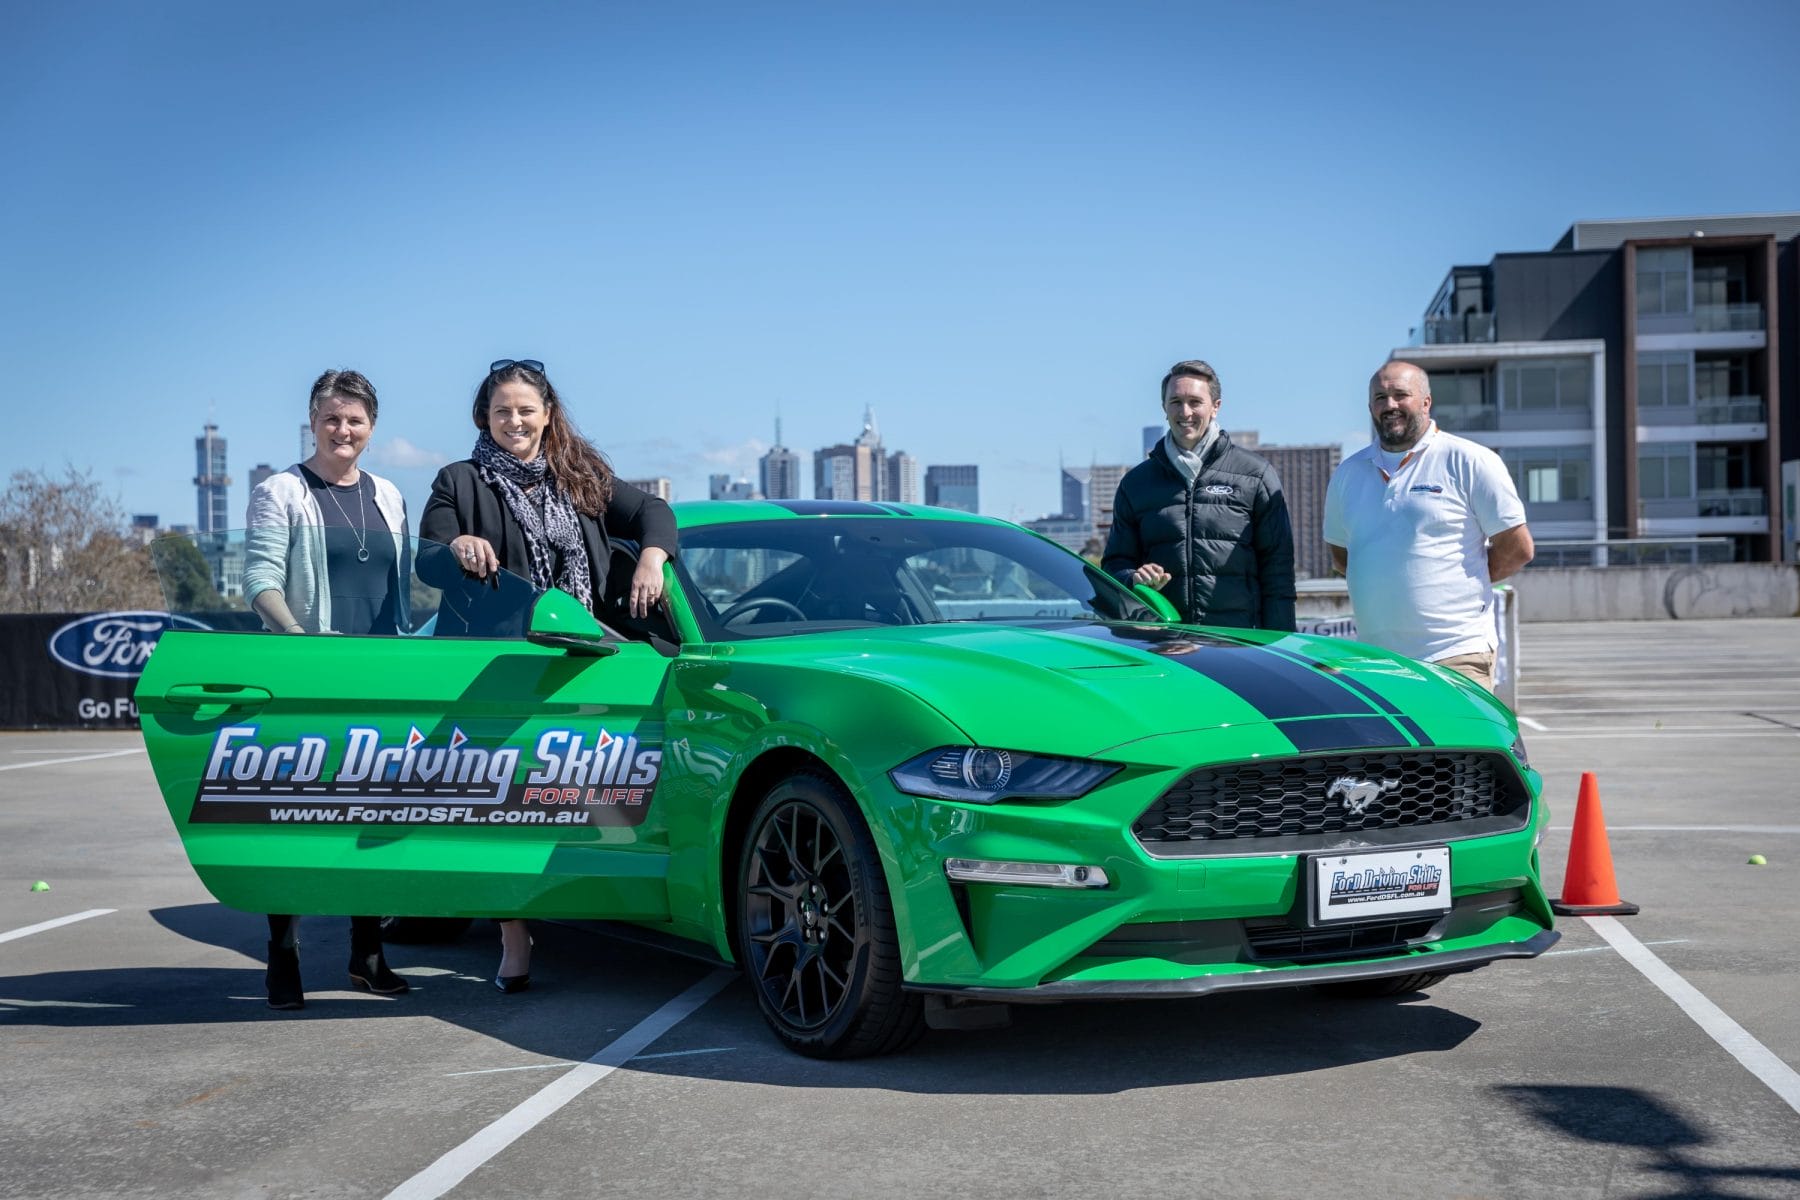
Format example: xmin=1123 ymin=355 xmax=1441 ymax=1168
xmin=1132 ymin=750 xmax=1530 ymax=856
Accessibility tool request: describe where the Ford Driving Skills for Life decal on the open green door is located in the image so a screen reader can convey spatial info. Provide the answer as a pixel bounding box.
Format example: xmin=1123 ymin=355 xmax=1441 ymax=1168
xmin=189 ymin=725 xmax=662 ymax=826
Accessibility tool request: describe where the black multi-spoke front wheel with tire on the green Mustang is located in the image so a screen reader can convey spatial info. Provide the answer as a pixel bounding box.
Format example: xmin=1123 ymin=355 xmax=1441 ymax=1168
xmin=736 ymin=772 xmax=925 ymax=1058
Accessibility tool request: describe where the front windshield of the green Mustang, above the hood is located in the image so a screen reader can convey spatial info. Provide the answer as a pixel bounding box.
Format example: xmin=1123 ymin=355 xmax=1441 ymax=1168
xmin=677 ymin=516 xmax=1161 ymax=640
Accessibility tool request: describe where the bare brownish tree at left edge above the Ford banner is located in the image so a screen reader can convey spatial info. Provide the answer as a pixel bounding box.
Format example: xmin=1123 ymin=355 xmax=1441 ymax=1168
xmin=0 ymin=466 xmax=162 ymax=612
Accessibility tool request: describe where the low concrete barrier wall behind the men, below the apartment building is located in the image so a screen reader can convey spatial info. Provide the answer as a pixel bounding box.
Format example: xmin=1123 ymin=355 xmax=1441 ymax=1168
xmin=1298 ymin=563 xmax=1800 ymax=622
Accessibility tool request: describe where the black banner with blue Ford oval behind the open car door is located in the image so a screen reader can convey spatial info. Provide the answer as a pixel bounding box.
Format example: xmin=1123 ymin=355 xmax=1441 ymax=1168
xmin=0 ymin=610 xmax=247 ymax=729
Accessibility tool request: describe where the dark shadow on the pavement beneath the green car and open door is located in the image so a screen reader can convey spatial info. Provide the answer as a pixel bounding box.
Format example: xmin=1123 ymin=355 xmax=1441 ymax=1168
xmin=0 ymin=905 xmax=1480 ymax=1094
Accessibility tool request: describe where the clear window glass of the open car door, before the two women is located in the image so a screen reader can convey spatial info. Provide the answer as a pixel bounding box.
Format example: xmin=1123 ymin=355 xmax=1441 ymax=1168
xmin=149 ymin=525 xmax=542 ymax=639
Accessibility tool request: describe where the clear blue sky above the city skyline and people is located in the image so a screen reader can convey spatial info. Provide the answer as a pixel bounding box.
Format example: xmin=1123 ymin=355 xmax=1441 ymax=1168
xmin=0 ymin=0 xmax=1800 ymax=522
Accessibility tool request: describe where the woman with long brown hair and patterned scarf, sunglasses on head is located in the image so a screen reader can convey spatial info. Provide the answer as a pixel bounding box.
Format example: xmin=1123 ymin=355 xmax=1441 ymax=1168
xmin=419 ymin=358 xmax=675 ymax=991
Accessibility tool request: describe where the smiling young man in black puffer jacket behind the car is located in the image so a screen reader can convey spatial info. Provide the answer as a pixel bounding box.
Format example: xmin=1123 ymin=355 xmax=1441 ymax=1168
xmin=1102 ymin=360 xmax=1294 ymax=630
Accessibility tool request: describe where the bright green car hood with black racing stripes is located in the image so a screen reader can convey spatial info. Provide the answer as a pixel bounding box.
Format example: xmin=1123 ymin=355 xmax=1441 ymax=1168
xmin=738 ymin=621 xmax=1512 ymax=756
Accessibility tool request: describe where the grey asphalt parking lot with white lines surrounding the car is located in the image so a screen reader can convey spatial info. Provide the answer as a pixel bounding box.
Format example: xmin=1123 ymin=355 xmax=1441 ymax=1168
xmin=0 ymin=621 xmax=1800 ymax=1198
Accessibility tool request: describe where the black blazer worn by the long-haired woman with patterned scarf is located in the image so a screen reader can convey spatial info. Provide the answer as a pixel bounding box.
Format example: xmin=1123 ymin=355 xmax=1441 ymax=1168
xmin=418 ymin=461 xmax=677 ymax=633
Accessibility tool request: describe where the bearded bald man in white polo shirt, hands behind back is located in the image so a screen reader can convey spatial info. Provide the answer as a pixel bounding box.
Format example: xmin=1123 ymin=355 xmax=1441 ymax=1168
xmin=1325 ymin=362 xmax=1534 ymax=689
